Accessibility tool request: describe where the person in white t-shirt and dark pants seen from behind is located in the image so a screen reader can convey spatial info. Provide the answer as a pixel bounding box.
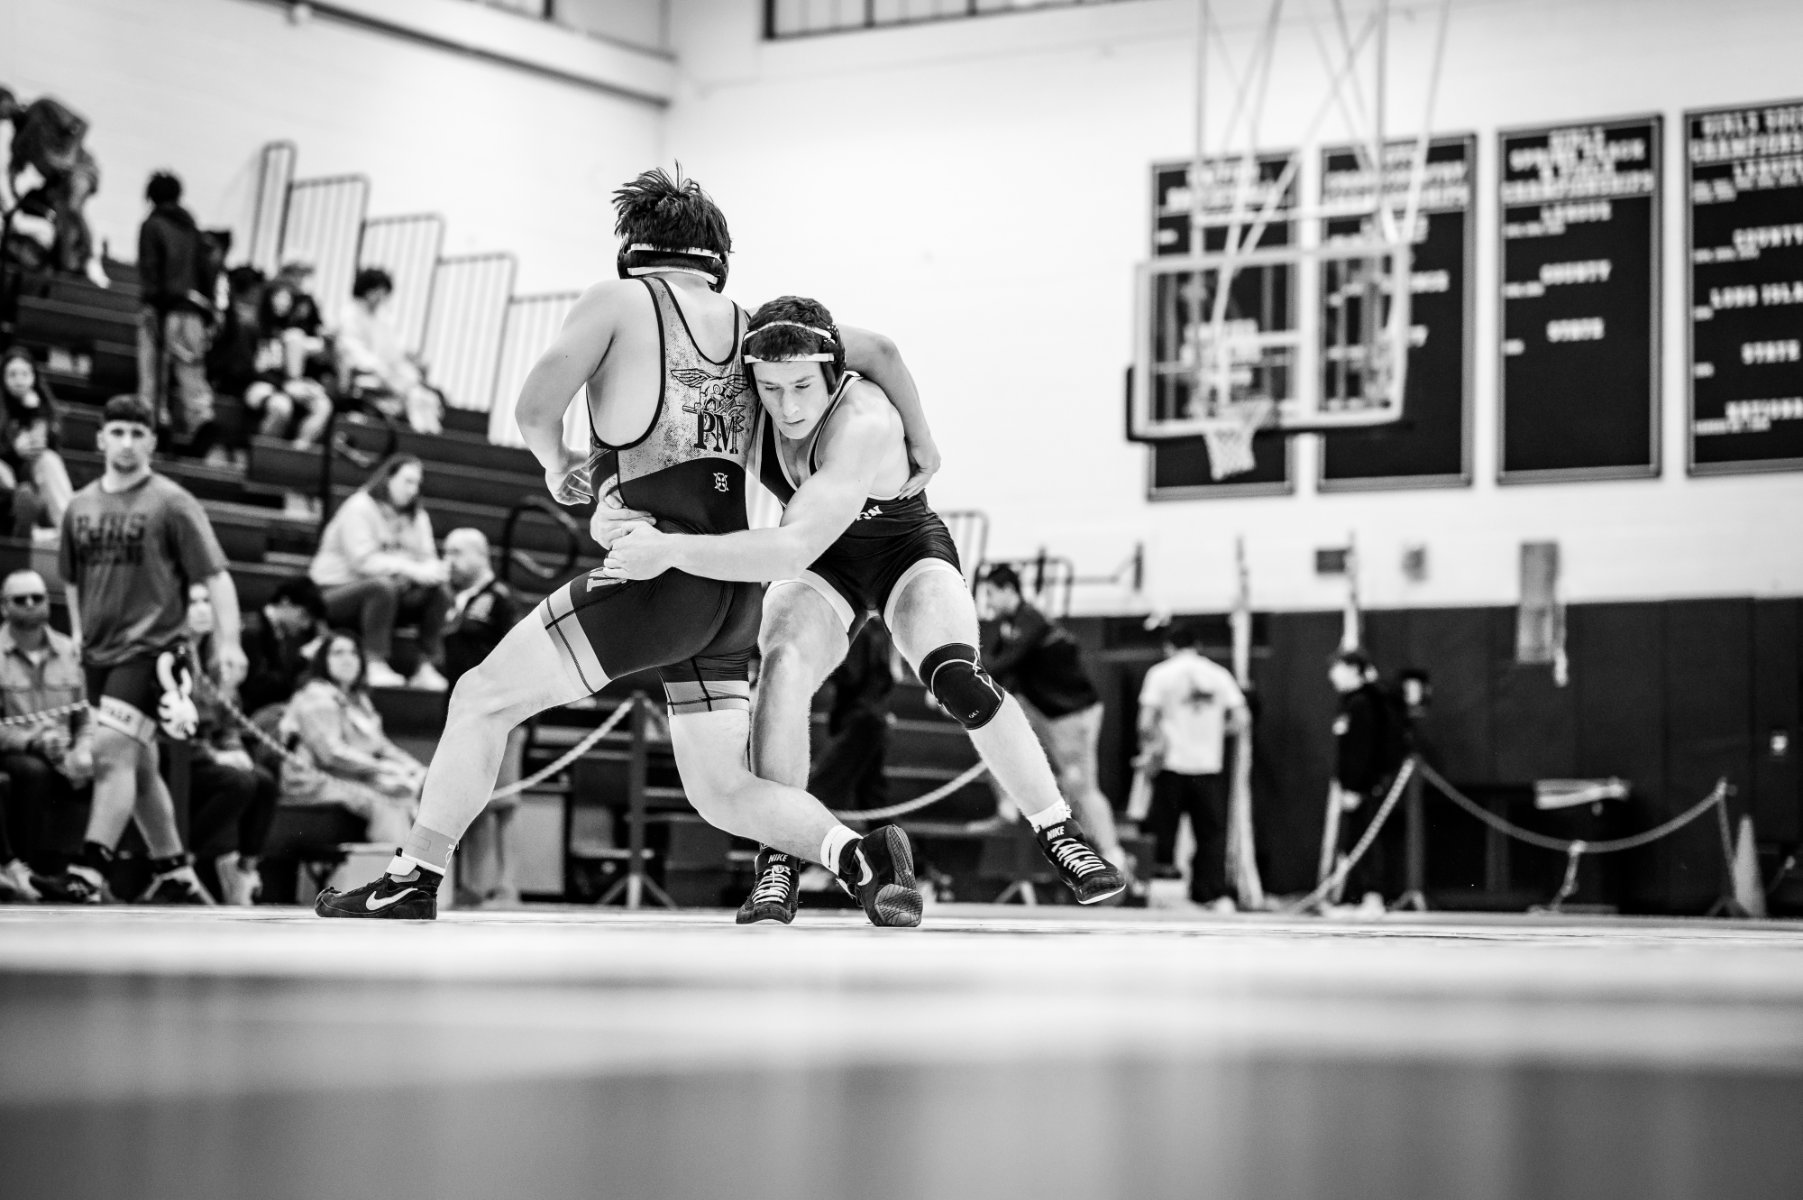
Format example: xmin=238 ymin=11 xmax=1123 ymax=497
xmin=1139 ymin=625 xmax=1246 ymax=908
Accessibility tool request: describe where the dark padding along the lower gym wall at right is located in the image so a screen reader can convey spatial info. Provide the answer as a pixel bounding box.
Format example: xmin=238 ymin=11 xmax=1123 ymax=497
xmin=1073 ymin=598 xmax=1803 ymax=912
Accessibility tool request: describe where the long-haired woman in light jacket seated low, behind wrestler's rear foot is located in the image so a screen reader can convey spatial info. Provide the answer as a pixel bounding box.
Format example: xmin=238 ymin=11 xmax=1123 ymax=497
xmin=279 ymin=631 xmax=426 ymax=843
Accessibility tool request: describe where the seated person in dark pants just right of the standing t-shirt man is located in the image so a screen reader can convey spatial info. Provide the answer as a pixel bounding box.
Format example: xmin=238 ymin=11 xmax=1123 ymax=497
xmin=188 ymin=584 xmax=278 ymax=905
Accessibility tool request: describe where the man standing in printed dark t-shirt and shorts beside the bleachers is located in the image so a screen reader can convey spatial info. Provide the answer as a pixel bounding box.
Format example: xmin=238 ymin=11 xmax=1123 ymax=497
xmin=49 ymin=396 xmax=245 ymax=905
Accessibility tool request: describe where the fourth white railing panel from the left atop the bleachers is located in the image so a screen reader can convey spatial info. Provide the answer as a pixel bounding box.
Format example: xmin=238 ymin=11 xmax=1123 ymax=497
xmin=424 ymin=254 xmax=514 ymax=413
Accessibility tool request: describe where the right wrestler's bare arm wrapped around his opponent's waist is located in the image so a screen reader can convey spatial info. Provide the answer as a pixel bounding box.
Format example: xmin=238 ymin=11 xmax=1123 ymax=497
xmin=602 ymin=400 xmax=892 ymax=582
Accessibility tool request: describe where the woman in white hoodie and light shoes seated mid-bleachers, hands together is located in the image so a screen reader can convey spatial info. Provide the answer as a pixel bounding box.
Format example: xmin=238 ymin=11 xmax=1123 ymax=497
xmin=308 ymin=454 xmax=451 ymax=692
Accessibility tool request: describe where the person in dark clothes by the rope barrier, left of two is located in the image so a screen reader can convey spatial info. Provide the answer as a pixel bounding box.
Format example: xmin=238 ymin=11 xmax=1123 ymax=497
xmin=1327 ymin=650 xmax=1403 ymax=914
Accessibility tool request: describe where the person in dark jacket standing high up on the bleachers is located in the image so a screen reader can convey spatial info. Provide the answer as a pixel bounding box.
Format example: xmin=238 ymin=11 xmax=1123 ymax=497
xmin=137 ymin=171 xmax=213 ymax=445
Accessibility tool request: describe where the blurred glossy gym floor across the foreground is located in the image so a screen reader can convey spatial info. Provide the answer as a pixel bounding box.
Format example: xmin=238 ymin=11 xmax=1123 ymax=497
xmin=0 ymin=905 xmax=1803 ymax=1200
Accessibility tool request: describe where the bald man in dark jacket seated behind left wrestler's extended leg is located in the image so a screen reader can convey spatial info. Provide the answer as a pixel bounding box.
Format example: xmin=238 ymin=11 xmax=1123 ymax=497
xmin=444 ymin=530 xmax=526 ymax=908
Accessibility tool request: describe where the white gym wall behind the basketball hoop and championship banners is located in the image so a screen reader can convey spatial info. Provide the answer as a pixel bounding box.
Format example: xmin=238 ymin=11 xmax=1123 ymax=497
xmin=667 ymin=0 xmax=1803 ymax=609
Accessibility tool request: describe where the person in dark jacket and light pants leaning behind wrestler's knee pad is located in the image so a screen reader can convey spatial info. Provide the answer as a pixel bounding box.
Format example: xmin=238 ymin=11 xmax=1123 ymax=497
xmin=983 ymin=564 xmax=1127 ymax=867
